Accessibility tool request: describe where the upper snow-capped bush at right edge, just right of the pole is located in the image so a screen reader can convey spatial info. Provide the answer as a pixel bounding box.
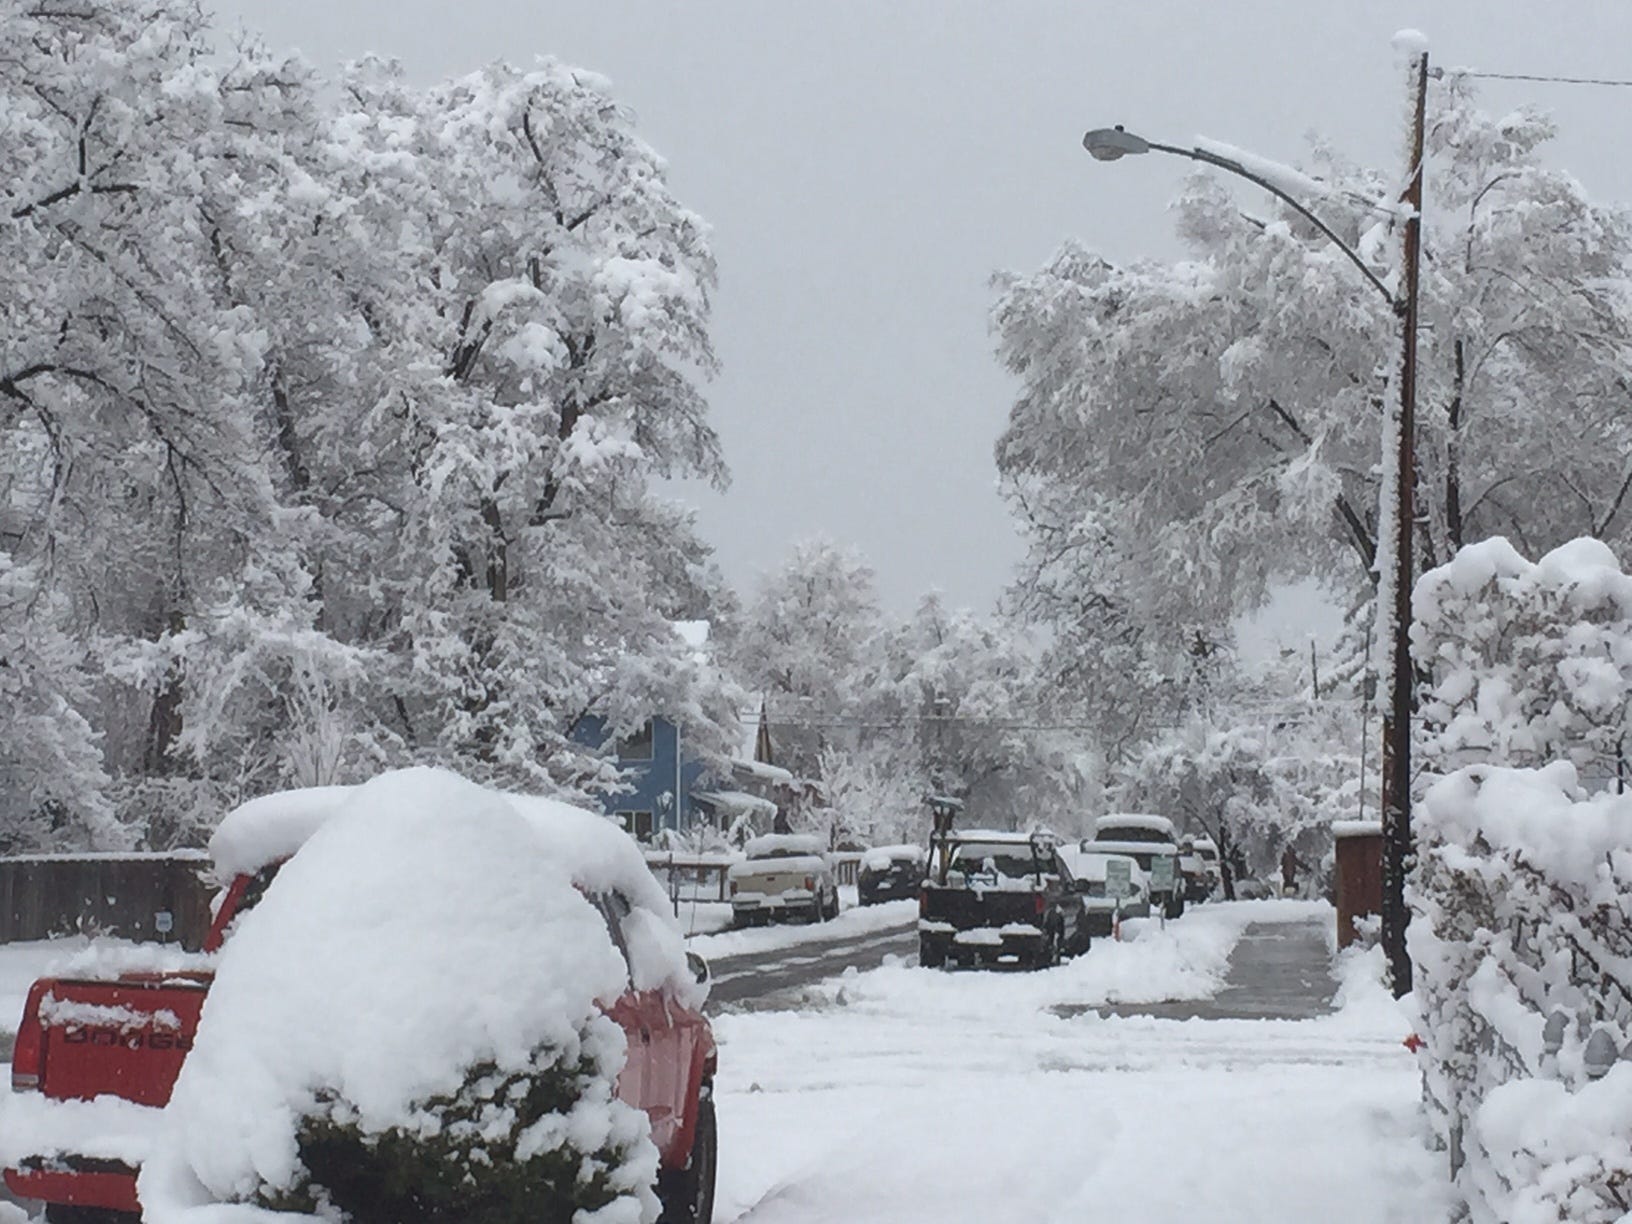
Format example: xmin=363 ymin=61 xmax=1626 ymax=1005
xmin=1412 ymin=537 xmax=1632 ymax=785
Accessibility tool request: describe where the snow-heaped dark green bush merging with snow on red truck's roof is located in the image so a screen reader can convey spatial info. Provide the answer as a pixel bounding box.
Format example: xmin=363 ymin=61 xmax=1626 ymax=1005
xmin=139 ymin=769 xmax=675 ymax=1224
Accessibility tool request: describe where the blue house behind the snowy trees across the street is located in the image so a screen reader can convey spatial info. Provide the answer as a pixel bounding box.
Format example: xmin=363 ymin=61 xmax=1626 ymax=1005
xmin=573 ymin=715 xmax=793 ymax=842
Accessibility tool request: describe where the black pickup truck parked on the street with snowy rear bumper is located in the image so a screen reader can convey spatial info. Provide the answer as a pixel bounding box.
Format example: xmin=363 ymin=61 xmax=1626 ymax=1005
xmin=919 ymin=829 xmax=1089 ymax=969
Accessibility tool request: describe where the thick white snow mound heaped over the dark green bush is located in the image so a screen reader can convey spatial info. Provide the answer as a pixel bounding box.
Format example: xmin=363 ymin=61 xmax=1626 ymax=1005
xmin=140 ymin=769 xmax=678 ymax=1224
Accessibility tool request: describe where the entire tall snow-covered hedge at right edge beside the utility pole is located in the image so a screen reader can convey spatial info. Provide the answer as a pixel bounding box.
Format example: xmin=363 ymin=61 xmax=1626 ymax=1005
xmin=1410 ymin=539 xmax=1632 ymax=1224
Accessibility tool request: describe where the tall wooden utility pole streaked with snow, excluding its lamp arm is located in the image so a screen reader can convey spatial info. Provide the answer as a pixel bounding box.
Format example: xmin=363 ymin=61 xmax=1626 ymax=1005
xmin=1376 ymin=31 xmax=1428 ymax=997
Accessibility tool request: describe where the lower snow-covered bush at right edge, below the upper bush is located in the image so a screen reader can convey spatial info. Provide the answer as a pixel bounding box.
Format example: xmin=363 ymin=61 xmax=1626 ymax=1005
xmin=1408 ymin=763 xmax=1632 ymax=1224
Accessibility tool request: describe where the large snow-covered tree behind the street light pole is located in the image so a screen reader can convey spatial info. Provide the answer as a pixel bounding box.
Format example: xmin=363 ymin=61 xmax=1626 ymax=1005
xmin=994 ymin=75 xmax=1632 ymax=747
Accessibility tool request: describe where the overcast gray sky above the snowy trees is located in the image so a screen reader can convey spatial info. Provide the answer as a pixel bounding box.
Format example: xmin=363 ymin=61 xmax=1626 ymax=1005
xmin=207 ymin=0 xmax=1632 ymax=610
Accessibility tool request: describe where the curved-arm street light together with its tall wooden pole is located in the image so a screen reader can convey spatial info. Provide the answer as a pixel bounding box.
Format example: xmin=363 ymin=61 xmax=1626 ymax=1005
xmin=1082 ymin=76 xmax=1428 ymax=996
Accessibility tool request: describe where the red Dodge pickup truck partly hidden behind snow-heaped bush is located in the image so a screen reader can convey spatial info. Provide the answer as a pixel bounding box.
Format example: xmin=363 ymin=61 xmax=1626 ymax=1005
xmin=5 ymin=796 xmax=716 ymax=1224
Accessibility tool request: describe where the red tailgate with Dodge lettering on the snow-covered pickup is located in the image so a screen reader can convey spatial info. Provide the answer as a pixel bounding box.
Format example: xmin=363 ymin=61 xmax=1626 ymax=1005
xmin=38 ymin=976 xmax=209 ymax=1106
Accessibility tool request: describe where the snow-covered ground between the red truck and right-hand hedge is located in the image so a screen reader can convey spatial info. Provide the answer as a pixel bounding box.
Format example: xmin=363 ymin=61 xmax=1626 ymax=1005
xmin=715 ymin=902 xmax=1444 ymax=1224
